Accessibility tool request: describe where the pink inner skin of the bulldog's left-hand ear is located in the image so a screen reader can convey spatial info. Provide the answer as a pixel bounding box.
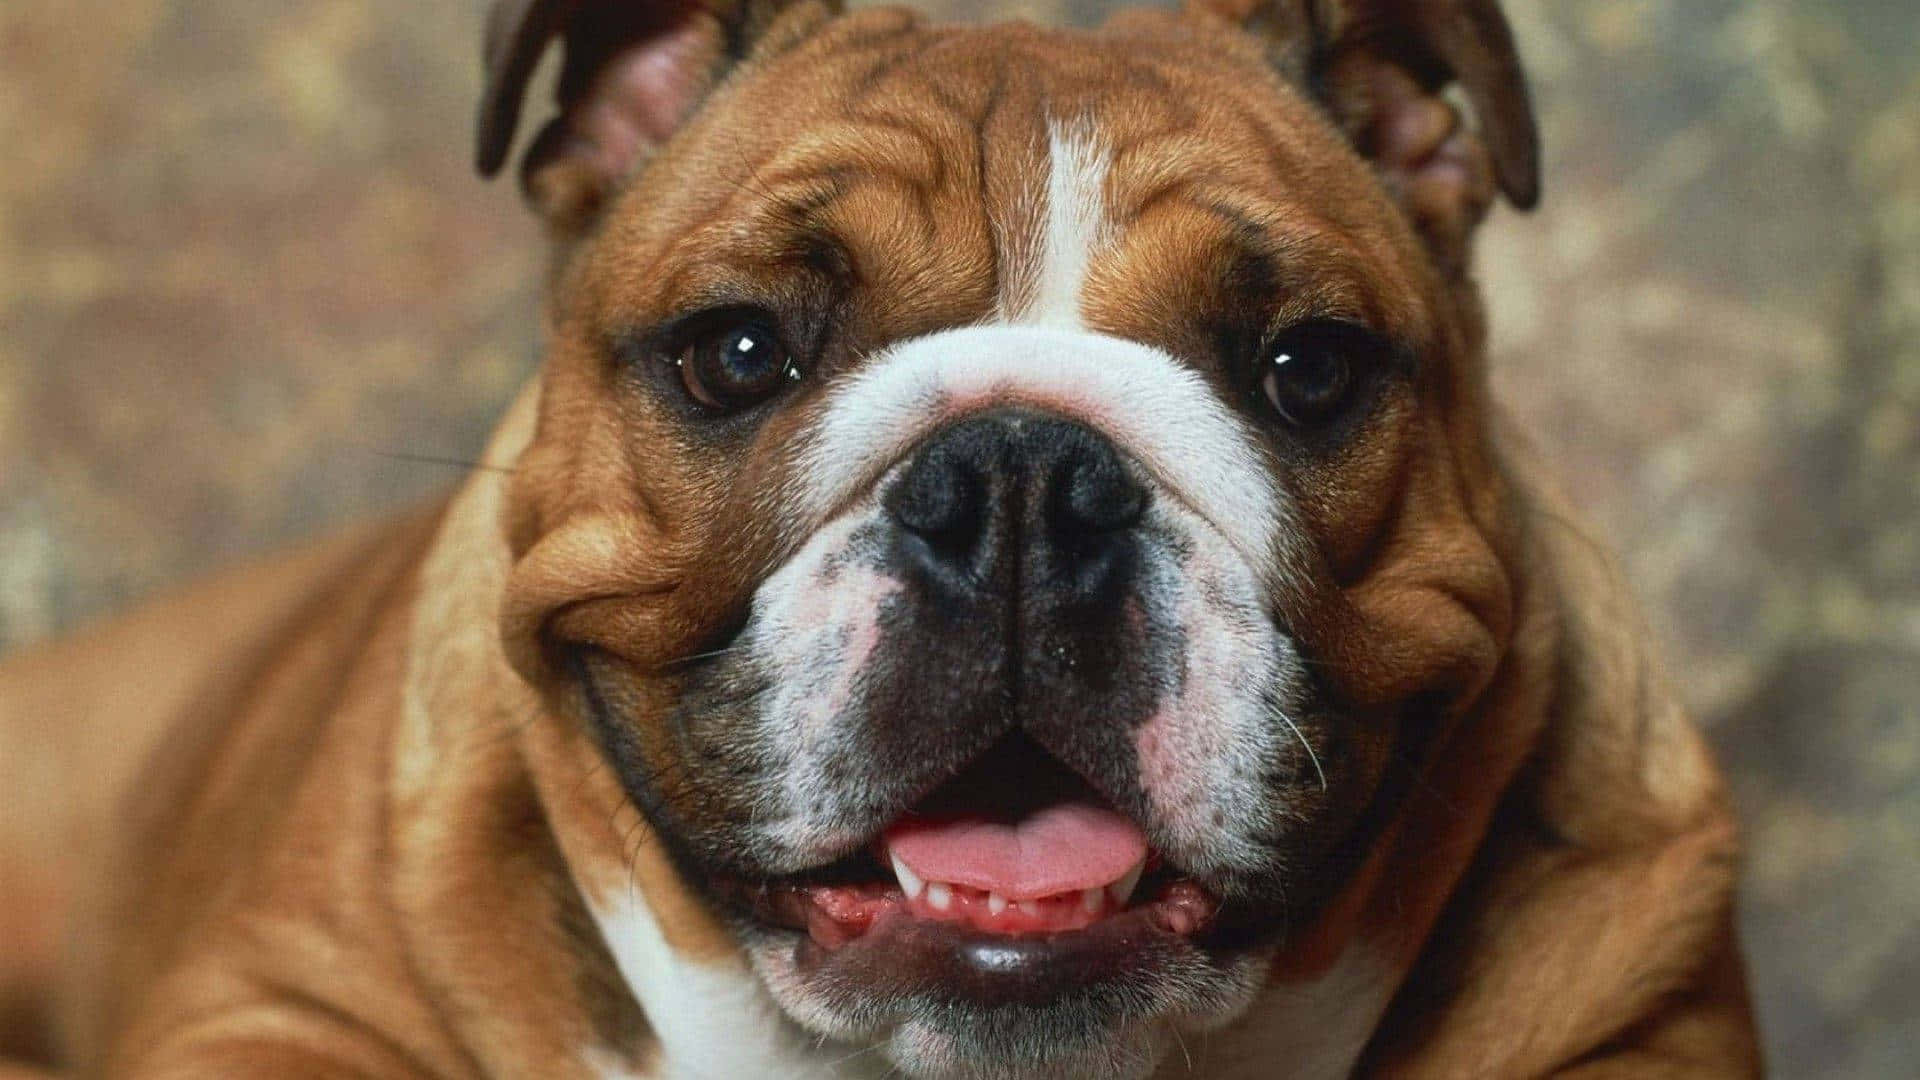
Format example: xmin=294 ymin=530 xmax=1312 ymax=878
xmin=572 ymin=17 xmax=716 ymax=177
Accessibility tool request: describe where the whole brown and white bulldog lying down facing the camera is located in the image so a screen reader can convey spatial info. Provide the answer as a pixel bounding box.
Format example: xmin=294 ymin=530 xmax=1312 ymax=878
xmin=0 ymin=0 xmax=1759 ymax=1080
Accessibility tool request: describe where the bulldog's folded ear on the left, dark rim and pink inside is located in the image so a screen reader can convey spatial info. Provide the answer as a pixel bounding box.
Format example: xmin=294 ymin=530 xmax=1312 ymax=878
xmin=476 ymin=0 xmax=839 ymax=233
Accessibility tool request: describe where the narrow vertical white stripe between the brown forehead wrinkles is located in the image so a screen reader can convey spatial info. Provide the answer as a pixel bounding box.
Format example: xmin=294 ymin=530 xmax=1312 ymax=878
xmin=1002 ymin=123 xmax=1112 ymax=329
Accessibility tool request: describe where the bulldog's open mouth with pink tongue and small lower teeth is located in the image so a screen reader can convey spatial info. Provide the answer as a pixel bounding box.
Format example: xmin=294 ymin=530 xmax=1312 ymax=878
xmin=721 ymin=738 xmax=1221 ymax=967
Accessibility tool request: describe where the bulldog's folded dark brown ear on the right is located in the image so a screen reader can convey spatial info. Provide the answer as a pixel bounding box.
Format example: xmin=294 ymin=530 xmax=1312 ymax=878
xmin=1187 ymin=0 xmax=1540 ymax=256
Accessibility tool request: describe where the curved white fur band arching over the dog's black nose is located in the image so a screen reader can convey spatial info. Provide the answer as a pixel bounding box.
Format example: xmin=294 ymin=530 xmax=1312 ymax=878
xmin=795 ymin=327 xmax=1294 ymax=580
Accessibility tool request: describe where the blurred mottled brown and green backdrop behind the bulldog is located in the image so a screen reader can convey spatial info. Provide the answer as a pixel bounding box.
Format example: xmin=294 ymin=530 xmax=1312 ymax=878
xmin=0 ymin=0 xmax=1920 ymax=1078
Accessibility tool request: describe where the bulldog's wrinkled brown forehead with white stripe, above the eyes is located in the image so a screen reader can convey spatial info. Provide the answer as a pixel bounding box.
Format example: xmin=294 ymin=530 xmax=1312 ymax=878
xmin=586 ymin=12 xmax=1432 ymax=356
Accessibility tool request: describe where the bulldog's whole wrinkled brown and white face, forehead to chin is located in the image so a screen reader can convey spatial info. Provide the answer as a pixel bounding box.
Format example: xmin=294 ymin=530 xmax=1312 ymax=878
xmin=487 ymin=4 xmax=1530 ymax=1076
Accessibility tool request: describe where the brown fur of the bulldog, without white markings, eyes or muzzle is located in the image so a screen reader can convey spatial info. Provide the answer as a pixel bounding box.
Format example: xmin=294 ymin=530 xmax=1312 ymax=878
xmin=0 ymin=4 xmax=1757 ymax=1078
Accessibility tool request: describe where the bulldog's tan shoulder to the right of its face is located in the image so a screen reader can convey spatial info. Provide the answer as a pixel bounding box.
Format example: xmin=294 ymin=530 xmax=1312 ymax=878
xmin=1367 ymin=418 xmax=1759 ymax=1076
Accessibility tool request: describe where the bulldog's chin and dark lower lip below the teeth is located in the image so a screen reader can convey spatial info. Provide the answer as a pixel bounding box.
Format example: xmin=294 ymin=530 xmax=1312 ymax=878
xmin=745 ymin=901 xmax=1271 ymax=1080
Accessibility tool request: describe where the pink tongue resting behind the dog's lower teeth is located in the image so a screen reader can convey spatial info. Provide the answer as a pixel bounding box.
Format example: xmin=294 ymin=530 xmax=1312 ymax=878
xmin=887 ymin=803 xmax=1146 ymax=899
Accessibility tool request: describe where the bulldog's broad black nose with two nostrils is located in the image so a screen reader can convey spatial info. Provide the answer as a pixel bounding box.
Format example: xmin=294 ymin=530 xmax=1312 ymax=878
xmin=885 ymin=411 xmax=1146 ymax=600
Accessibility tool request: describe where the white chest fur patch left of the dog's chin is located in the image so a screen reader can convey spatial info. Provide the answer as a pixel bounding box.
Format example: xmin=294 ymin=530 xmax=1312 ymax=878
xmin=582 ymin=894 xmax=885 ymax=1080
